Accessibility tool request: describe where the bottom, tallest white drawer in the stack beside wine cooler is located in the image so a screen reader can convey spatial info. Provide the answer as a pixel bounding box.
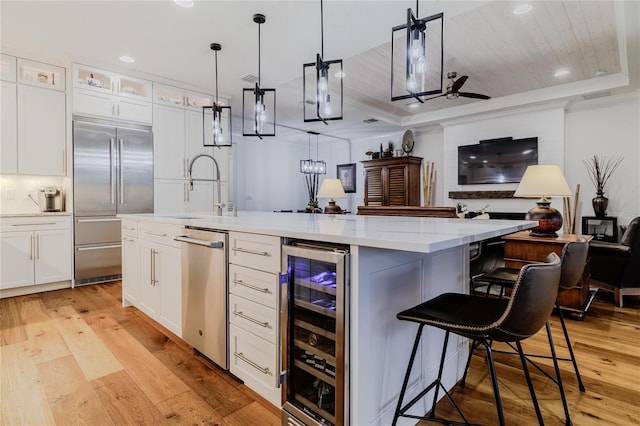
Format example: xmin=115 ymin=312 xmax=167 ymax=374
xmin=229 ymin=324 xmax=278 ymax=399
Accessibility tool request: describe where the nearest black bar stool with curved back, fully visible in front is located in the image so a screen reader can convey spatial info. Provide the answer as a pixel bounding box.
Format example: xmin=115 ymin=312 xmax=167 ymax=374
xmin=393 ymin=253 xmax=561 ymax=425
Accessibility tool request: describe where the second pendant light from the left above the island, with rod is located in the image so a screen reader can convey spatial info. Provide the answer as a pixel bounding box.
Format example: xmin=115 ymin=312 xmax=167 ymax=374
xmin=242 ymin=13 xmax=276 ymax=139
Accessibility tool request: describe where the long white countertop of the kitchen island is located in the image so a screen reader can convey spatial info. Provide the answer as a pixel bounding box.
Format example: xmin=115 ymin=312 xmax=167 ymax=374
xmin=118 ymin=211 xmax=537 ymax=253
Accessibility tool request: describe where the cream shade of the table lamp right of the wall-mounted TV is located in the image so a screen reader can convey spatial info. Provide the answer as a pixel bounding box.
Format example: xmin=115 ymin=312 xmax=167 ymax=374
xmin=513 ymin=164 xmax=572 ymax=198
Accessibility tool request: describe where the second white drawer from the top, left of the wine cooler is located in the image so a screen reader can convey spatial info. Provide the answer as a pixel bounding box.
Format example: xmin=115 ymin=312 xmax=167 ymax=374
xmin=229 ymin=265 xmax=279 ymax=309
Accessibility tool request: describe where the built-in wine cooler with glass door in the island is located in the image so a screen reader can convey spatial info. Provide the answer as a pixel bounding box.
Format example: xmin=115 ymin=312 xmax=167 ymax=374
xmin=282 ymin=241 xmax=349 ymax=426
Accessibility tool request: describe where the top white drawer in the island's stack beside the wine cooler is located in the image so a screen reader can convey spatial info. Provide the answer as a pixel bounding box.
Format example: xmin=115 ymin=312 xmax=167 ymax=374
xmin=229 ymin=232 xmax=280 ymax=272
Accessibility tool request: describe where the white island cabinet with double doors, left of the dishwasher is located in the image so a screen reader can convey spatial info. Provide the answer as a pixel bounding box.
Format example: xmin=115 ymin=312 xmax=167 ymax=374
xmin=122 ymin=220 xmax=182 ymax=336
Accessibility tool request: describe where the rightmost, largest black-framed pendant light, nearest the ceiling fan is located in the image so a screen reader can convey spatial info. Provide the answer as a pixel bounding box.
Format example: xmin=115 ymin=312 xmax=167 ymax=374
xmin=391 ymin=0 xmax=444 ymax=103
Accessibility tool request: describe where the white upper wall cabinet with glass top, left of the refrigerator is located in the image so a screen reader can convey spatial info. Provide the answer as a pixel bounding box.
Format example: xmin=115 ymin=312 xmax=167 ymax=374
xmin=0 ymin=55 xmax=66 ymax=176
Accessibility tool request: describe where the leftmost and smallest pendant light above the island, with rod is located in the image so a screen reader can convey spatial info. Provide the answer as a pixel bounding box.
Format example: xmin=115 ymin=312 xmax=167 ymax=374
xmin=202 ymin=43 xmax=231 ymax=147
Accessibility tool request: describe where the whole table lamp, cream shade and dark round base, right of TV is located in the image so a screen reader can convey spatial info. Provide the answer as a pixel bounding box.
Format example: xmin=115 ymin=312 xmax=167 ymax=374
xmin=513 ymin=164 xmax=572 ymax=238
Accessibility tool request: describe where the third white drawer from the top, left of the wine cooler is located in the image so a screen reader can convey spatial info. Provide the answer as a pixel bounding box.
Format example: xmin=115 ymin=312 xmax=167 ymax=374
xmin=229 ymin=294 xmax=278 ymax=343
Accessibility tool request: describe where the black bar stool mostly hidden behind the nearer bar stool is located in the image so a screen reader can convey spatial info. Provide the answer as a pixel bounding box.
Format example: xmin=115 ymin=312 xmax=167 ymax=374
xmin=462 ymin=238 xmax=589 ymax=424
